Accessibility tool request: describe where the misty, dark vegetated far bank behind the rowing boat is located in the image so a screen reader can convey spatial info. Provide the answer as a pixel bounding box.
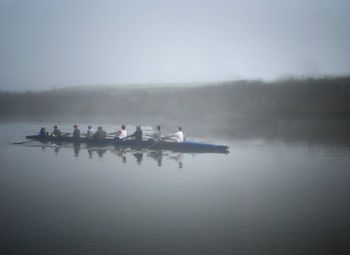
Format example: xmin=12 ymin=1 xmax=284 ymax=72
xmin=0 ymin=77 xmax=350 ymax=122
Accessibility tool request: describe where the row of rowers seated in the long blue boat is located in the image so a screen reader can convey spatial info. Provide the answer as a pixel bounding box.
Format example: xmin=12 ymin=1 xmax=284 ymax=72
xmin=39 ymin=125 xmax=185 ymax=143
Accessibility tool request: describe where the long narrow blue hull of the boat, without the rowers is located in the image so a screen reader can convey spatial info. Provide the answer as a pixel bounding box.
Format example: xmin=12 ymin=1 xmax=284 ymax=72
xmin=26 ymin=135 xmax=229 ymax=153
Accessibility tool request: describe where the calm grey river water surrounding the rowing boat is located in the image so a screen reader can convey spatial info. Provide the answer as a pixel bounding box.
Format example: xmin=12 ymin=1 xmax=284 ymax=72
xmin=0 ymin=123 xmax=350 ymax=254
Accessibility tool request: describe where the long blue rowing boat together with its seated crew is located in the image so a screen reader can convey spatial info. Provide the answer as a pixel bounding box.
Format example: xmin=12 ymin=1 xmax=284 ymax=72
xmin=26 ymin=124 xmax=229 ymax=153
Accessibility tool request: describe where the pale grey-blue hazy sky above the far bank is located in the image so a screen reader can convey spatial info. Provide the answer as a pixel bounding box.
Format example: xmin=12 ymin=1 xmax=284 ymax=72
xmin=0 ymin=0 xmax=350 ymax=90
